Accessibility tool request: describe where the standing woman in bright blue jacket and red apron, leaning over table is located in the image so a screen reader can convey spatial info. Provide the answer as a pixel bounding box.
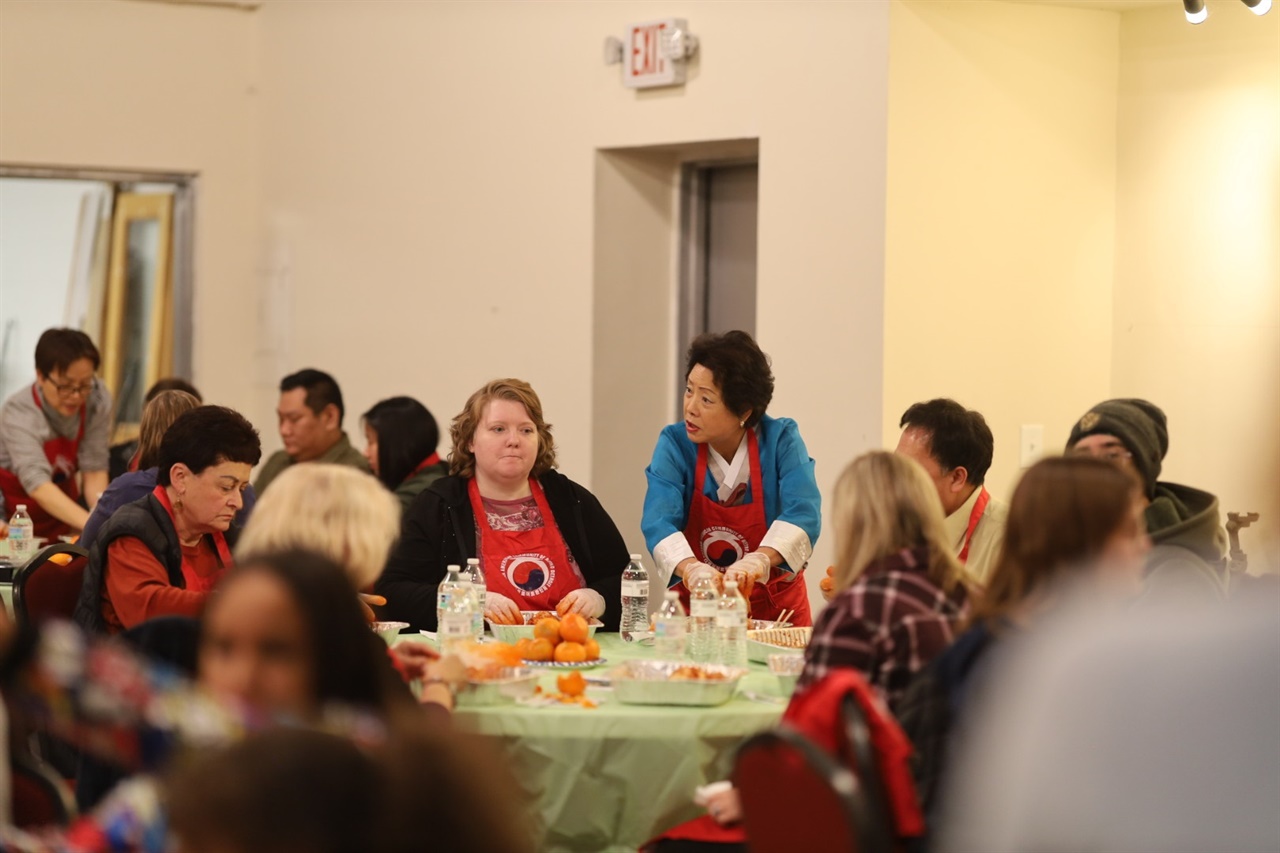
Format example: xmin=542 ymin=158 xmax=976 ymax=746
xmin=641 ymin=330 xmax=822 ymax=625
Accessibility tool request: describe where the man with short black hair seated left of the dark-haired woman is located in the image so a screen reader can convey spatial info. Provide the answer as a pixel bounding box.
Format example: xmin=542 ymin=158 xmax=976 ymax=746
xmin=253 ymin=368 xmax=369 ymax=497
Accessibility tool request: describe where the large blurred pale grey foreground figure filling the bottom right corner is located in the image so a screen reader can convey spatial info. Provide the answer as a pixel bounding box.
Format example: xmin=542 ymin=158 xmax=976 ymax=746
xmin=940 ymin=597 xmax=1280 ymax=853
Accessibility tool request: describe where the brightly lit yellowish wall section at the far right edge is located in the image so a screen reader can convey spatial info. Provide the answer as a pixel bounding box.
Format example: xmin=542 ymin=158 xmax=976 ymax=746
xmin=1116 ymin=3 xmax=1280 ymax=571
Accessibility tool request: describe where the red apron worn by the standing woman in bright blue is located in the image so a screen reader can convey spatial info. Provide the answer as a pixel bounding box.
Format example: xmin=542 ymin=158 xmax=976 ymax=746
xmin=678 ymin=429 xmax=813 ymax=626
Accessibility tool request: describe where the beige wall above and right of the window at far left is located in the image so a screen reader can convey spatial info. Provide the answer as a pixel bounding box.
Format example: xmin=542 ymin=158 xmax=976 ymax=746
xmin=0 ymin=0 xmax=261 ymax=417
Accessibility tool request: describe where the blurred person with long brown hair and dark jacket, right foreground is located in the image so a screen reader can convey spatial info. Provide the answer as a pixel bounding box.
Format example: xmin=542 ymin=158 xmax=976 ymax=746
xmin=896 ymin=459 xmax=1151 ymax=840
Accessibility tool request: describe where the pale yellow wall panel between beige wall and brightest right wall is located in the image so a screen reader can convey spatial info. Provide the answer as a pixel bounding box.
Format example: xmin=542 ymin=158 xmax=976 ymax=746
xmin=883 ymin=0 xmax=1120 ymax=498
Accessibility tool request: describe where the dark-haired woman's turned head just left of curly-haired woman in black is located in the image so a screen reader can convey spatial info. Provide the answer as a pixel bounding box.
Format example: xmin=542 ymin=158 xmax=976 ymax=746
xmin=361 ymin=397 xmax=449 ymax=511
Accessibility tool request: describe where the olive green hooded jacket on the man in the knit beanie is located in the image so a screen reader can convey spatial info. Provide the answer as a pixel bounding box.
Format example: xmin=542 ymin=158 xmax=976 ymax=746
xmin=1143 ymin=483 xmax=1226 ymax=601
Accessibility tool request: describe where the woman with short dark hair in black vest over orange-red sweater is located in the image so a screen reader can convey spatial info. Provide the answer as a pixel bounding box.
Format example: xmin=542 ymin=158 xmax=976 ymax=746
xmin=76 ymin=406 xmax=262 ymax=634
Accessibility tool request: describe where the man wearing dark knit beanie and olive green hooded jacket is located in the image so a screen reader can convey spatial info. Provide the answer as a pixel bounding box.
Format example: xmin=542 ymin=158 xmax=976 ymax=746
xmin=1066 ymin=400 xmax=1226 ymax=599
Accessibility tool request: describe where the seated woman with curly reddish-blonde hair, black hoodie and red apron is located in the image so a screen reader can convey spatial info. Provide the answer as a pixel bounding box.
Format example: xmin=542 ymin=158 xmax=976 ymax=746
xmin=376 ymin=379 xmax=628 ymax=630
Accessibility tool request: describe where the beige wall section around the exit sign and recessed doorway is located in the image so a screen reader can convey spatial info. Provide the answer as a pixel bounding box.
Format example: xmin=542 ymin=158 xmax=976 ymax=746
xmin=261 ymin=1 xmax=888 ymax=604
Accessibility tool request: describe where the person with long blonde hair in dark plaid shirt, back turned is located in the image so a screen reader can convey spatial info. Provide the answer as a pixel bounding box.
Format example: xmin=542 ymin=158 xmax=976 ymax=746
xmin=796 ymin=451 xmax=969 ymax=707
